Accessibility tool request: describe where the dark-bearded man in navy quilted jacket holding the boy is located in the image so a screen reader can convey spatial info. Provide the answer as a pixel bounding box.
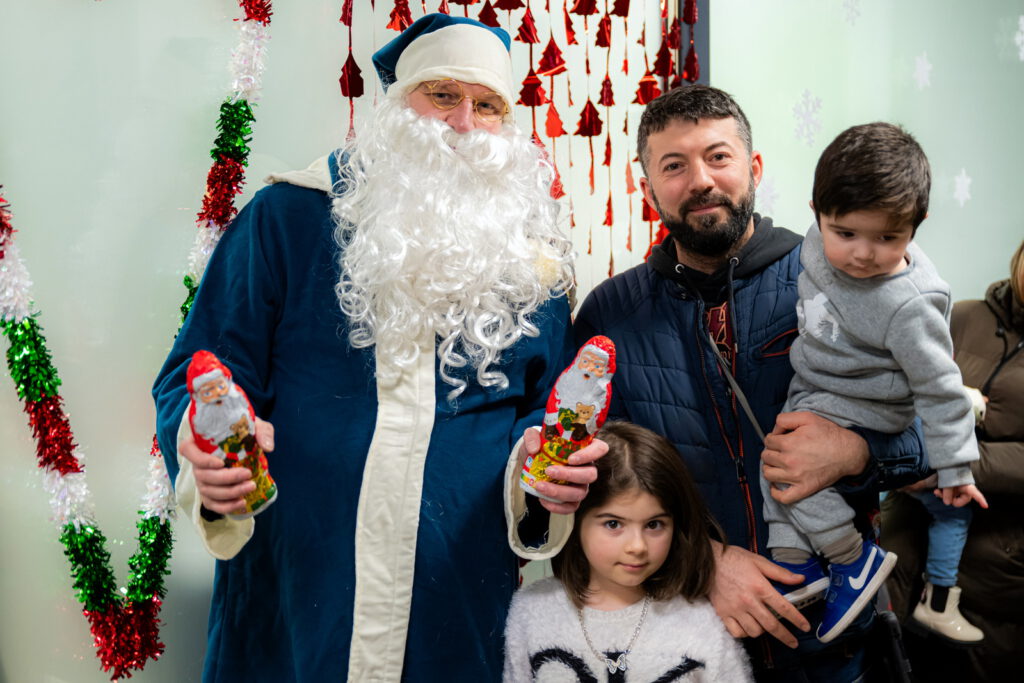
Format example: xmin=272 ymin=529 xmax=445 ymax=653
xmin=574 ymin=85 xmax=925 ymax=683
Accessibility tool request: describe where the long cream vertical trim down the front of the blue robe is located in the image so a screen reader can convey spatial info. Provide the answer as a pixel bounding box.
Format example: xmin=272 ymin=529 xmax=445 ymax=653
xmin=348 ymin=336 xmax=436 ymax=683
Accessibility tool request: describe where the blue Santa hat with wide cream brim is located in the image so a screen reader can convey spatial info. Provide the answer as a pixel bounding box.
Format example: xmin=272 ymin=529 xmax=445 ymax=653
xmin=374 ymin=13 xmax=515 ymax=120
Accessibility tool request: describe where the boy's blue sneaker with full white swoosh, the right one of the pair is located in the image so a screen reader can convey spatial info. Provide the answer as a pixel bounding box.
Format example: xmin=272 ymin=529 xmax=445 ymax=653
xmin=817 ymin=541 xmax=896 ymax=643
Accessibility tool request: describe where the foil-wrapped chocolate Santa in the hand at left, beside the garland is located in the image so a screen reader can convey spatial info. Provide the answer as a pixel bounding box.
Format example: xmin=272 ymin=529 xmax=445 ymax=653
xmin=185 ymin=350 xmax=278 ymax=519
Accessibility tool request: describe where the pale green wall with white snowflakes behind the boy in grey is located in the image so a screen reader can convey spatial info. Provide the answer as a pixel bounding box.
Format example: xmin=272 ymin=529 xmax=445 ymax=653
xmin=710 ymin=0 xmax=1024 ymax=299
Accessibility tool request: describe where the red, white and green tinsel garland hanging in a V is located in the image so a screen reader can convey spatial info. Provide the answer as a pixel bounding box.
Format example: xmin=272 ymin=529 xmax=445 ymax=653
xmin=0 ymin=0 xmax=271 ymax=680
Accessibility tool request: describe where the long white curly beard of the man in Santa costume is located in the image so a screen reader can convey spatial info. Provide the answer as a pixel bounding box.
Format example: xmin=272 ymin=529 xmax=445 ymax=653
xmin=334 ymin=96 xmax=572 ymax=400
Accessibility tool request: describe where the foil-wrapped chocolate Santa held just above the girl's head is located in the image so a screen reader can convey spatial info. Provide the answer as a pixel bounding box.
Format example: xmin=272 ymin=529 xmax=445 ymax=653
xmin=519 ymin=337 xmax=615 ymax=498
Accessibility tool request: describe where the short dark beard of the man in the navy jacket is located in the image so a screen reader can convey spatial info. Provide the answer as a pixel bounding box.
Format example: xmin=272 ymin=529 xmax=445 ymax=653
xmin=655 ymin=177 xmax=755 ymax=256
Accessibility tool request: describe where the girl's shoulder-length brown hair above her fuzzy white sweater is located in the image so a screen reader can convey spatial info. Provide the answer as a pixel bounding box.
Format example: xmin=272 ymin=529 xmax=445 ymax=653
xmin=551 ymin=422 xmax=722 ymax=607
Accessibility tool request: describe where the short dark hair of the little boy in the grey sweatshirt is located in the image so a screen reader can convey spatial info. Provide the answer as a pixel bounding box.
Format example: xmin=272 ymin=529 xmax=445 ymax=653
xmin=812 ymin=122 xmax=932 ymax=232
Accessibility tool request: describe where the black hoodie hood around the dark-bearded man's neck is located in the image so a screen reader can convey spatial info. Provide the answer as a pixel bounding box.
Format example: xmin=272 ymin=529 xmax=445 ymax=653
xmin=647 ymin=213 xmax=804 ymax=305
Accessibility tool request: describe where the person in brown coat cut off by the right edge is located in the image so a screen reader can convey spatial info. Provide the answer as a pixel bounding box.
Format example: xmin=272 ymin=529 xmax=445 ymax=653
xmin=882 ymin=243 xmax=1024 ymax=681
